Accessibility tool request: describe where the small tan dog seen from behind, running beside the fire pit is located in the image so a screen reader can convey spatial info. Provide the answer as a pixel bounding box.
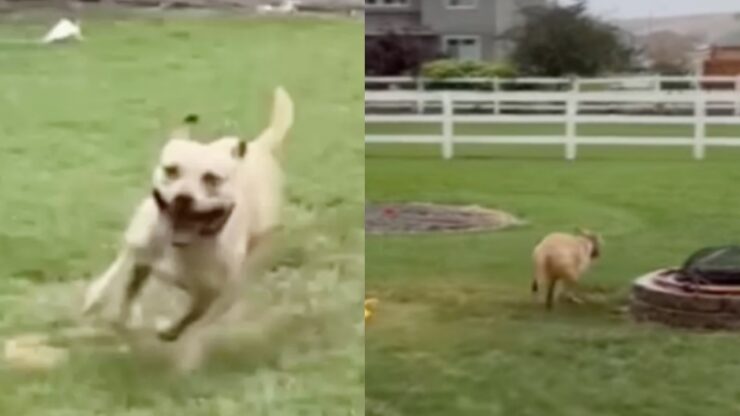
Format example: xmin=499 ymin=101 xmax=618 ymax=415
xmin=532 ymin=230 xmax=603 ymax=309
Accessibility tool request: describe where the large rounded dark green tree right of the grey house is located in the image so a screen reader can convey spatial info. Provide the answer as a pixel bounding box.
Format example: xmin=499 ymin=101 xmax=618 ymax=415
xmin=505 ymin=1 xmax=634 ymax=77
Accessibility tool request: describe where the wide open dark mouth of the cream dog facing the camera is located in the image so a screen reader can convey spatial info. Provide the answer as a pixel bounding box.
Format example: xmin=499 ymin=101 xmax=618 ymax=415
xmin=154 ymin=191 xmax=233 ymax=247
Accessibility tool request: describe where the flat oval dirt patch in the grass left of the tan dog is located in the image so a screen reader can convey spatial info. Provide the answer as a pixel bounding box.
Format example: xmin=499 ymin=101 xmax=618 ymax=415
xmin=365 ymin=202 xmax=522 ymax=234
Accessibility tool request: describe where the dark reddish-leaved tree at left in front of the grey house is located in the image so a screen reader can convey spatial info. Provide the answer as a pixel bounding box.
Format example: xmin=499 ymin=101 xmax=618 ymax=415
xmin=365 ymin=32 xmax=436 ymax=76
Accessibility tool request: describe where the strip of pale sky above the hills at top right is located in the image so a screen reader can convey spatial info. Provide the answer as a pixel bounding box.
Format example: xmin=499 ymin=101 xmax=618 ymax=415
xmin=559 ymin=0 xmax=740 ymax=18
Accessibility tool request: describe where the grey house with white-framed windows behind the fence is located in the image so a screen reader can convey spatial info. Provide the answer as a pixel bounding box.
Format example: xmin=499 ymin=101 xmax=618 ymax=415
xmin=365 ymin=0 xmax=548 ymax=61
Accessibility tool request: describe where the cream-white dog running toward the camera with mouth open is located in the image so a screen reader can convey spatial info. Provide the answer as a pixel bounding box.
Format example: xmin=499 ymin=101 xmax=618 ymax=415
xmin=83 ymin=88 xmax=293 ymax=341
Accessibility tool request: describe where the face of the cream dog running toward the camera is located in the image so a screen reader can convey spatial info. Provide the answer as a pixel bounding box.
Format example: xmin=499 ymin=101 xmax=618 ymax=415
xmin=153 ymin=135 xmax=246 ymax=247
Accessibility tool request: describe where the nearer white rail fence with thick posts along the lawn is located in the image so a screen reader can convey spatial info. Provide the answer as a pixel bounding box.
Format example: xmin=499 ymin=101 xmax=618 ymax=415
xmin=365 ymin=90 xmax=740 ymax=160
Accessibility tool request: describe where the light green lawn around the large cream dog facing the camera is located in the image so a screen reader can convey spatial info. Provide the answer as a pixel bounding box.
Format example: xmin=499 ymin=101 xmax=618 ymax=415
xmin=0 ymin=9 xmax=364 ymax=416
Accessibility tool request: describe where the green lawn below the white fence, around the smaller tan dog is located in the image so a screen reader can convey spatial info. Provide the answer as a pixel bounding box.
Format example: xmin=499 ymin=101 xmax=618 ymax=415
xmin=366 ymin=141 xmax=740 ymax=416
